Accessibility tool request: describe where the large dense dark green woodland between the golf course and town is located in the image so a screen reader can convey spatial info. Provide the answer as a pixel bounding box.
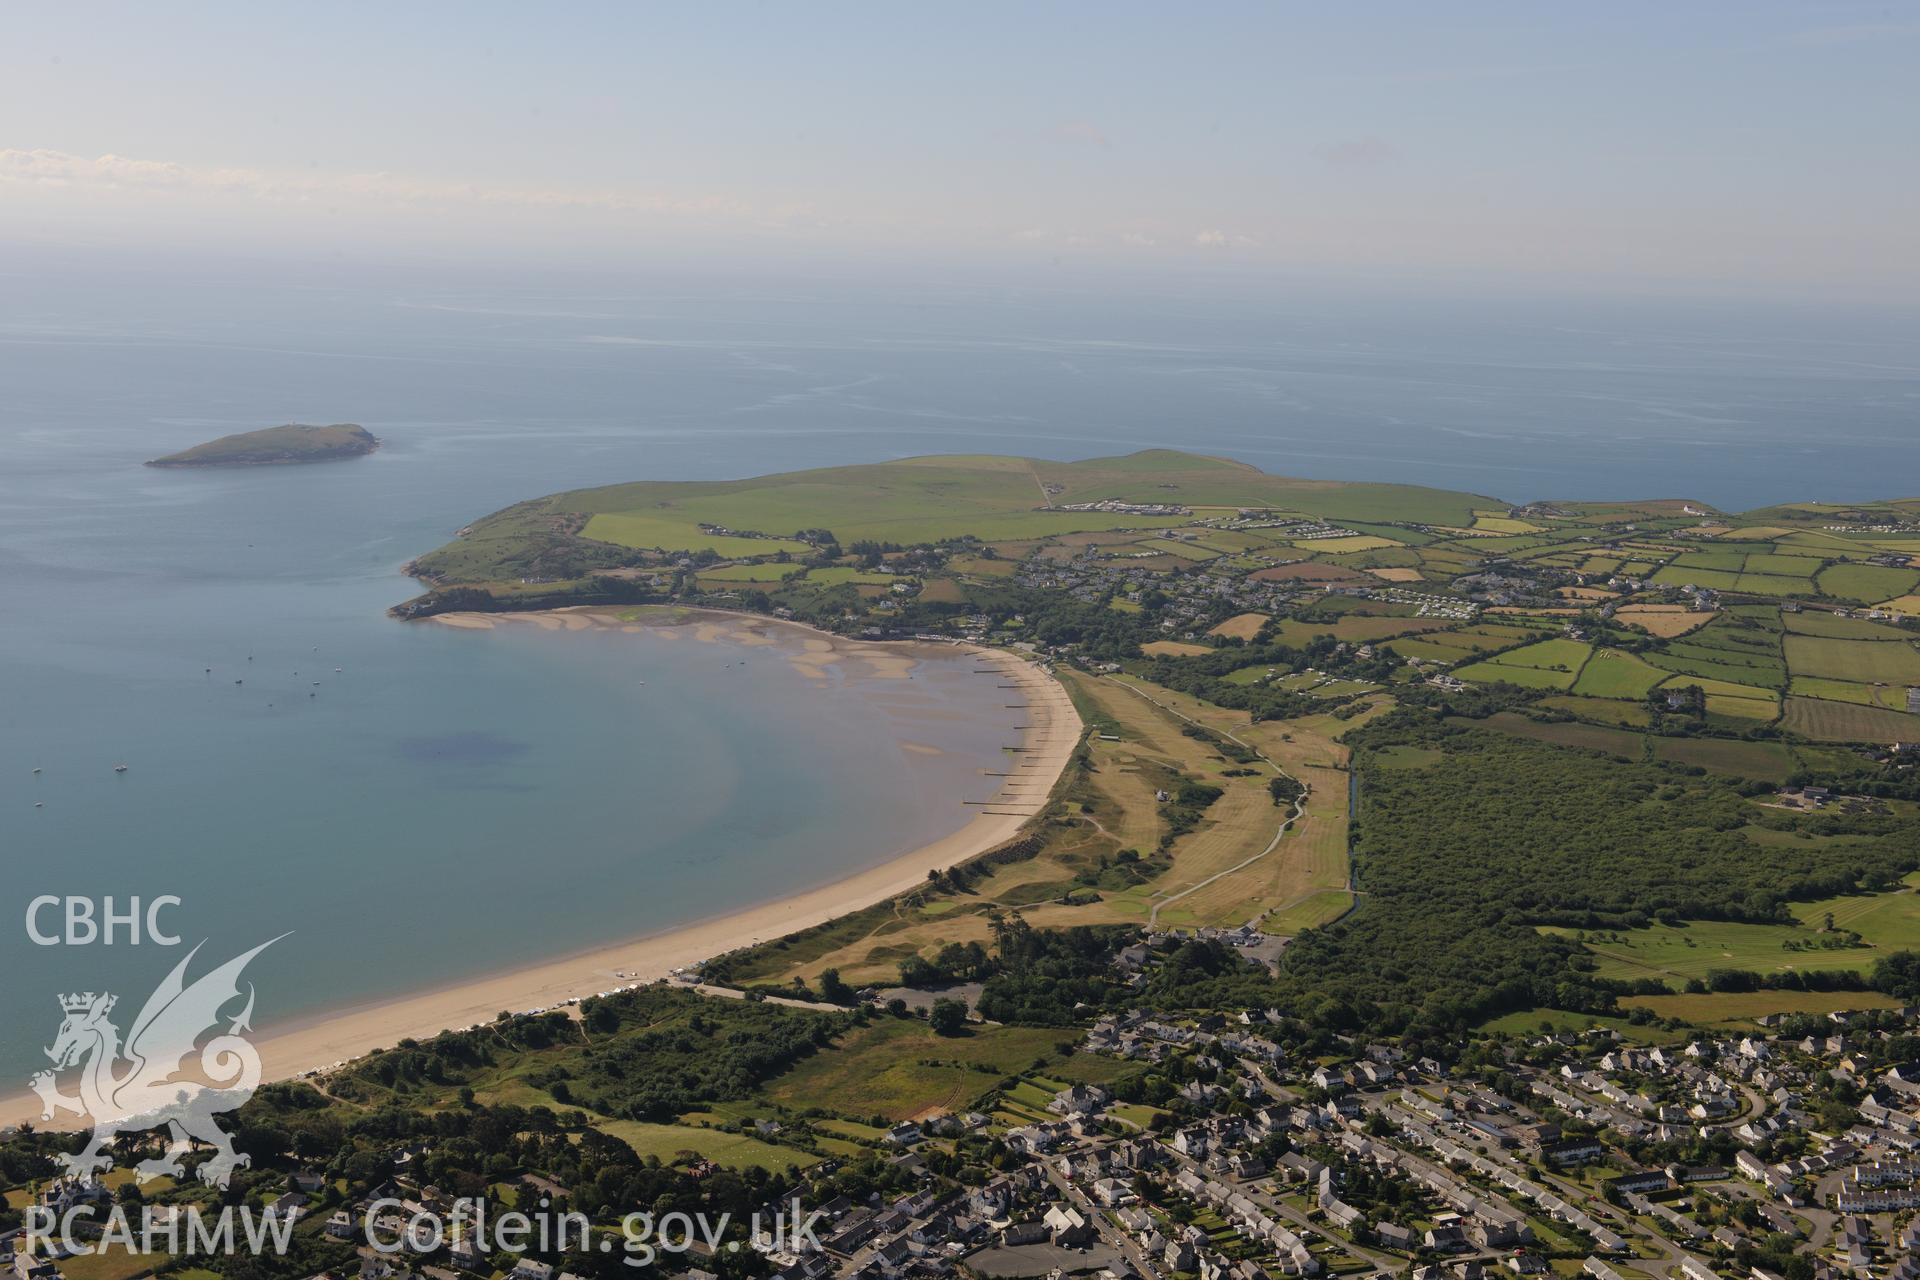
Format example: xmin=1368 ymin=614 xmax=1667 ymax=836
xmin=1121 ymin=710 xmax=1920 ymax=1038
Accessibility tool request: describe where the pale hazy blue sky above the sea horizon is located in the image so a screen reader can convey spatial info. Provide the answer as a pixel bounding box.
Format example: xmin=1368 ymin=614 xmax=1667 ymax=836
xmin=0 ymin=0 xmax=1920 ymax=305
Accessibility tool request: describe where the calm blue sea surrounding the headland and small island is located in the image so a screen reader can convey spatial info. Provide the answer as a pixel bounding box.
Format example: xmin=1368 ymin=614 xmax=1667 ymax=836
xmin=0 ymin=257 xmax=1920 ymax=1094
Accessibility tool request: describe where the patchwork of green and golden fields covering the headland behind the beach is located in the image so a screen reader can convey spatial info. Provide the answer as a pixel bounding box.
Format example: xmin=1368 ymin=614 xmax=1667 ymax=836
xmin=409 ymin=451 xmax=1920 ymax=1036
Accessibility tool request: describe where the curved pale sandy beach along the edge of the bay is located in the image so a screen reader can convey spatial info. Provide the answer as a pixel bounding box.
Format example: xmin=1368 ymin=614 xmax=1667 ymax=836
xmin=0 ymin=608 xmax=1083 ymax=1126
